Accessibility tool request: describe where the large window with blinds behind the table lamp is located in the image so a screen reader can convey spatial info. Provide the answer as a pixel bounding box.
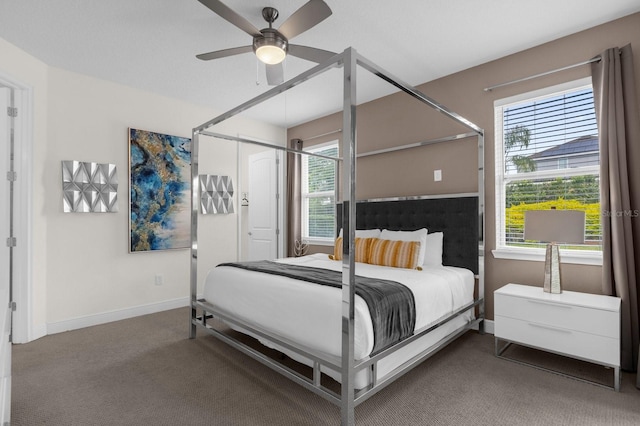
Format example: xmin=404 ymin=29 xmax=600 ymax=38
xmin=494 ymin=79 xmax=602 ymax=263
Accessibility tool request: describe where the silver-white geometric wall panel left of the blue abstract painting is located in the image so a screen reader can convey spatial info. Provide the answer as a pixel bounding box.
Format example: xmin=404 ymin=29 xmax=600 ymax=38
xmin=62 ymin=161 xmax=118 ymax=213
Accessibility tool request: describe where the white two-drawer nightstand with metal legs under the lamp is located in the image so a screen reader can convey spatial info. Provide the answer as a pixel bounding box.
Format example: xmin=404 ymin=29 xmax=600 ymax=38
xmin=493 ymin=284 xmax=620 ymax=391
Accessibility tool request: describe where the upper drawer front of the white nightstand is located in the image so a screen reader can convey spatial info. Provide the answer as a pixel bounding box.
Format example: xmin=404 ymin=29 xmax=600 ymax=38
xmin=495 ymin=292 xmax=620 ymax=339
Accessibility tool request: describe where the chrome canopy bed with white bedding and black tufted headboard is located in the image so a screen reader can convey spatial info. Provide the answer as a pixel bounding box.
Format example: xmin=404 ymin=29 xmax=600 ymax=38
xmin=189 ymin=49 xmax=484 ymax=425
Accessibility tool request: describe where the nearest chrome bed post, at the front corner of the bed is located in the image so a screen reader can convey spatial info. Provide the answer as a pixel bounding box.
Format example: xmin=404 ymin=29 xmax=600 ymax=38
xmin=340 ymin=48 xmax=356 ymax=426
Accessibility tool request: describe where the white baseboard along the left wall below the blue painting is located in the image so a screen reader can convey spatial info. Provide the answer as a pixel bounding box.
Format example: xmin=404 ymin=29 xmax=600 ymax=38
xmin=47 ymin=297 xmax=190 ymax=334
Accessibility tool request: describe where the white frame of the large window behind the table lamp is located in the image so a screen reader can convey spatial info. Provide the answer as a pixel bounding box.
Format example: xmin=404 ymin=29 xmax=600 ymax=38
xmin=491 ymin=77 xmax=602 ymax=265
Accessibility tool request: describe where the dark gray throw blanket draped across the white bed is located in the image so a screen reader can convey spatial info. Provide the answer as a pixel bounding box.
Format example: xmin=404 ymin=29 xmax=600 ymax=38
xmin=218 ymin=260 xmax=416 ymax=355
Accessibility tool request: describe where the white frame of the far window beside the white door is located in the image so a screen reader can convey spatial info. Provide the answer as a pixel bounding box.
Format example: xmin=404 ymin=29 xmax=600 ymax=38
xmin=300 ymin=140 xmax=340 ymax=246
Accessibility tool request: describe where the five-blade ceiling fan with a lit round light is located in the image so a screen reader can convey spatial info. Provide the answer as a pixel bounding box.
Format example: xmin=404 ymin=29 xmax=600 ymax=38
xmin=196 ymin=0 xmax=335 ymax=85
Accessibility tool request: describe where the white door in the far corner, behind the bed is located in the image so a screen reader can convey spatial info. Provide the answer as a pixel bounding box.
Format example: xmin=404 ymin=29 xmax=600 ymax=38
xmin=248 ymin=150 xmax=283 ymax=260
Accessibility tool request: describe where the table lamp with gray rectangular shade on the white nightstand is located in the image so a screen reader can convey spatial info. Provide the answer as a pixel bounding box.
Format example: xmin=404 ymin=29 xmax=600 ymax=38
xmin=524 ymin=209 xmax=585 ymax=293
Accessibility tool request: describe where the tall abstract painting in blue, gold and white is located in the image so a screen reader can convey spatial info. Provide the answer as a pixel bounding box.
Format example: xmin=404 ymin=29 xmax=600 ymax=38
xmin=129 ymin=128 xmax=191 ymax=253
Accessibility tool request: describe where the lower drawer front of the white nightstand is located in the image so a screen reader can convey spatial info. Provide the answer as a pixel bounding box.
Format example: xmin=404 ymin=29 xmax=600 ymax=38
xmin=494 ymin=315 xmax=620 ymax=366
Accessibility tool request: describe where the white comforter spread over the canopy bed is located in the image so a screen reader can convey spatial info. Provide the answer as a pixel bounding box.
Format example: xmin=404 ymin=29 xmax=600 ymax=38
xmin=204 ymin=254 xmax=474 ymax=360
